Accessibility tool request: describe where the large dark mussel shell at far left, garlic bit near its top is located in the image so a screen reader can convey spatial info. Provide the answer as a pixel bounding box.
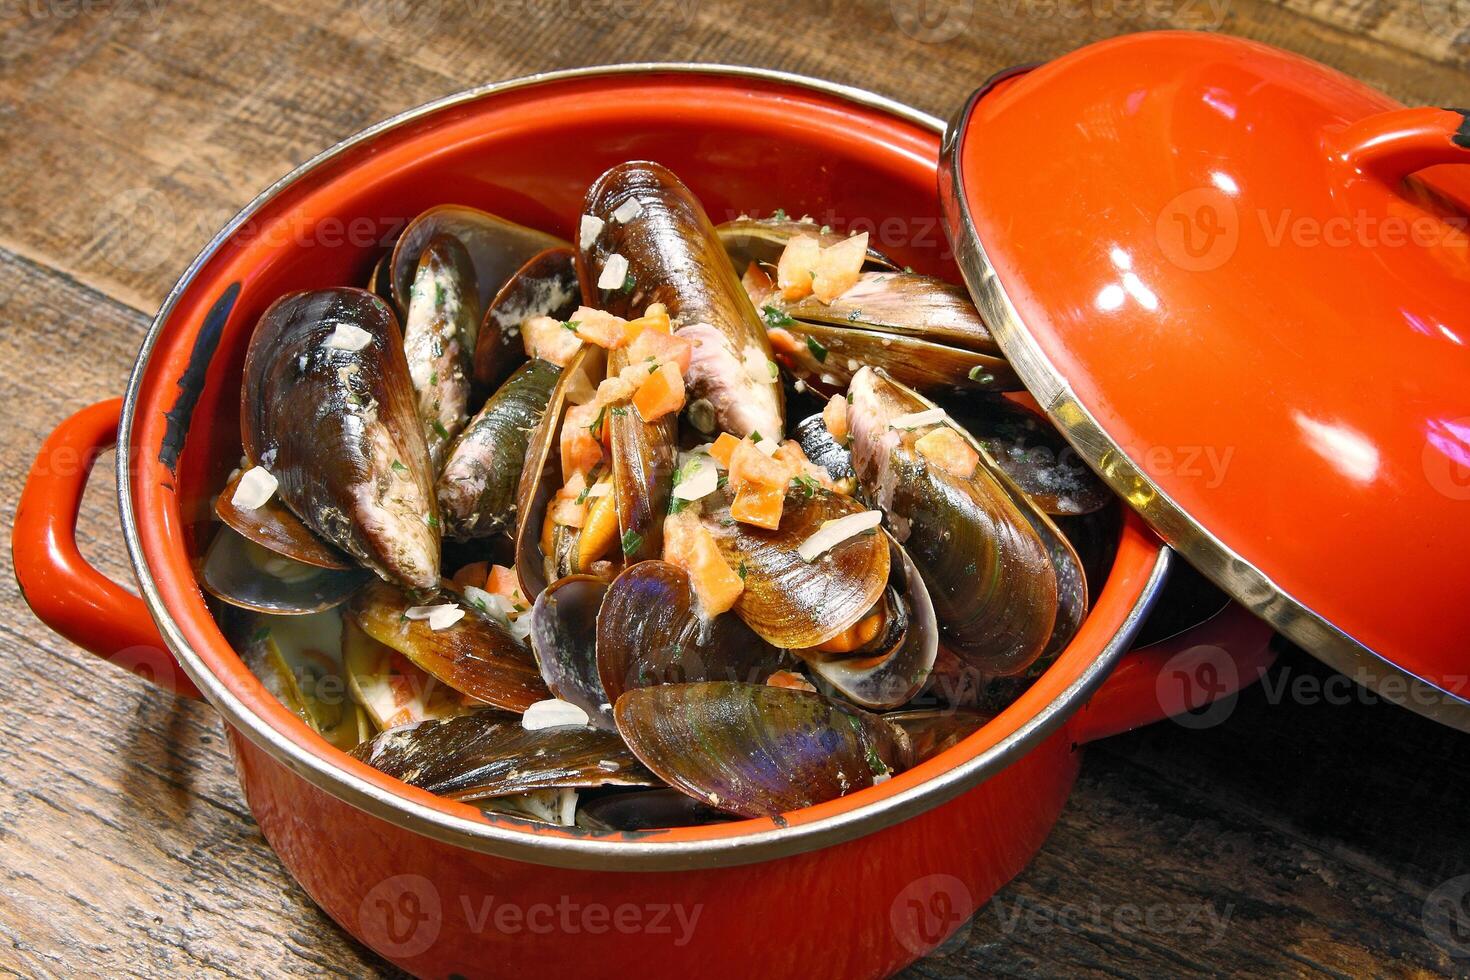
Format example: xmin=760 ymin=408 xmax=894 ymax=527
xmin=241 ymin=288 xmax=440 ymax=589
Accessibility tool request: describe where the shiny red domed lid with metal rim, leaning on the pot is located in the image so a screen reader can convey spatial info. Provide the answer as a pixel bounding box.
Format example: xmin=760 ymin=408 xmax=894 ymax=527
xmin=941 ymin=32 xmax=1470 ymax=730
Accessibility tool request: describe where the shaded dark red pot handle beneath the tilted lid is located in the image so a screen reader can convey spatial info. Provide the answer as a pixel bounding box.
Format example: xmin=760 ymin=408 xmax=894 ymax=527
xmin=1072 ymin=602 xmax=1276 ymax=743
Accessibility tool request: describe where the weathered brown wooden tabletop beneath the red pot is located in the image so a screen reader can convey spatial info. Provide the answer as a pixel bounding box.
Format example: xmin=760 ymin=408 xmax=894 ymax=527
xmin=0 ymin=0 xmax=1470 ymax=977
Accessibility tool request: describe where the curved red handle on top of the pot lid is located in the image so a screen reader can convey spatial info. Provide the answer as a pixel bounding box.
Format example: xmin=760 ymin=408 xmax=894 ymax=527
xmin=1329 ymin=107 xmax=1470 ymax=182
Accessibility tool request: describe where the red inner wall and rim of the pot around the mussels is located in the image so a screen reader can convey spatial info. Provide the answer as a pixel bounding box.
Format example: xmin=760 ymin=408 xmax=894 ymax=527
xmin=125 ymin=69 xmax=1158 ymax=863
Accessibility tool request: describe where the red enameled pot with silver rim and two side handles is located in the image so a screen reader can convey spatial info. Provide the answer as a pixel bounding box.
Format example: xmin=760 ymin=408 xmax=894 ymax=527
xmin=13 ymin=65 xmax=1270 ymax=977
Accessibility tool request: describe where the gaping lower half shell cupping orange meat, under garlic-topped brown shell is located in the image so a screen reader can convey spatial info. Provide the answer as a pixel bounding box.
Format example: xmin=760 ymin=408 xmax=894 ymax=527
xmin=795 ymin=535 xmax=939 ymax=710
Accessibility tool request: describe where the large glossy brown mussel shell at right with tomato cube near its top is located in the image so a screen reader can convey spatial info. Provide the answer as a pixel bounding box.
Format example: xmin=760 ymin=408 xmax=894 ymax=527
xmin=848 ymin=369 xmax=1064 ymax=676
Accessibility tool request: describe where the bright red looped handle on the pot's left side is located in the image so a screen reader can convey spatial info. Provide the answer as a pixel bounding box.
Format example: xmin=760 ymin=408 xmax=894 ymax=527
xmin=10 ymin=398 xmax=200 ymax=698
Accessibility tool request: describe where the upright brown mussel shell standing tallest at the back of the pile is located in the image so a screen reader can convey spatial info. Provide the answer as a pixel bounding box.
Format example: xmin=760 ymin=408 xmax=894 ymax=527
xmin=576 ymin=162 xmax=785 ymax=438
